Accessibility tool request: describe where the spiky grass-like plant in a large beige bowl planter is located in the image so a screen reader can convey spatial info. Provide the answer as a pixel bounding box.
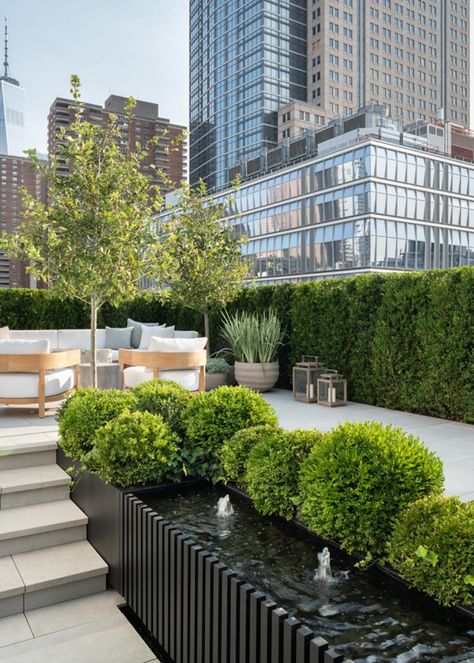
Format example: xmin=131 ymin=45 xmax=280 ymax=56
xmin=222 ymin=311 xmax=283 ymax=391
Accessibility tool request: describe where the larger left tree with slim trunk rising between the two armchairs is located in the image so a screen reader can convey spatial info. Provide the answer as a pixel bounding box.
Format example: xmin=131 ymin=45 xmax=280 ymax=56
xmin=1 ymin=76 xmax=170 ymax=386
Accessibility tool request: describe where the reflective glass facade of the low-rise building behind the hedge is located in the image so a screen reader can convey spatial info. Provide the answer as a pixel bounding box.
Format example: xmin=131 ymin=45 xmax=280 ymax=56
xmin=217 ymin=140 xmax=474 ymax=281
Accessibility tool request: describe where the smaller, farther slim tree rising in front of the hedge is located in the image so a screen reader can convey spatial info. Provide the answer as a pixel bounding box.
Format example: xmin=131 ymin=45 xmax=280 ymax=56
xmin=167 ymin=180 xmax=248 ymax=348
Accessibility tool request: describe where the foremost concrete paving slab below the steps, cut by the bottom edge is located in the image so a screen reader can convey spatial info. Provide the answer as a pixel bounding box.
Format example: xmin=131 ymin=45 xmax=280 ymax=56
xmin=0 ymin=610 xmax=155 ymax=663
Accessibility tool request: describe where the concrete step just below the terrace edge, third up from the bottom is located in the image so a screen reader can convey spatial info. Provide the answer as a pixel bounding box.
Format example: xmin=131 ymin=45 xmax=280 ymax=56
xmin=0 ymin=465 xmax=71 ymax=509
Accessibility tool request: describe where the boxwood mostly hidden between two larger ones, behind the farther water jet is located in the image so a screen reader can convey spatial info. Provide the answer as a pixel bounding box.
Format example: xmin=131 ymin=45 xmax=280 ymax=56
xmin=221 ymin=425 xmax=280 ymax=487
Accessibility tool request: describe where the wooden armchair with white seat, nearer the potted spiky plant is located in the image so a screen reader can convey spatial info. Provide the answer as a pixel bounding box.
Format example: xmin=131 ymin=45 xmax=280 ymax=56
xmin=119 ymin=350 xmax=207 ymax=391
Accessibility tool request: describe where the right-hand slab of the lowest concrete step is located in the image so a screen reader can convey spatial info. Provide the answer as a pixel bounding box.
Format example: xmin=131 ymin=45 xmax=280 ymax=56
xmin=12 ymin=541 xmax=108 ymax=611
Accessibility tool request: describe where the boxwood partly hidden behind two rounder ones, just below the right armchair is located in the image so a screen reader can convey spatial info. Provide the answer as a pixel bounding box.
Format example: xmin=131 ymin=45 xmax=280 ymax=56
xmin=131 ymin=380 xmax=192 ymax=434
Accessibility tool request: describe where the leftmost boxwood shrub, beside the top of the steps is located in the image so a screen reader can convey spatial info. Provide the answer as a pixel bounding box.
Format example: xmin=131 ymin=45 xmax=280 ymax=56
xmin=58 ymin=387 xmax=135 ymax=461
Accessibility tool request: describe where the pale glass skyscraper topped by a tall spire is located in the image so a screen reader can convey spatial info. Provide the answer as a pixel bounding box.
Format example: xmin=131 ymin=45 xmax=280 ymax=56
xmin=0 ymin=18 xmax=27 ymax=156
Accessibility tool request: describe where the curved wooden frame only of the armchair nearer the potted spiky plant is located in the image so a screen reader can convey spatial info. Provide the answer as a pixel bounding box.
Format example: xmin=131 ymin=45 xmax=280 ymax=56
xmin=119 ymin=349 xmax=207 ymax=391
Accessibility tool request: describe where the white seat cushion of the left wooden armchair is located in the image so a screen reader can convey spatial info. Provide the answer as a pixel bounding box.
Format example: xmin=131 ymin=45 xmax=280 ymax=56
xmin=0 ymin=368 xmax=74 ymax=398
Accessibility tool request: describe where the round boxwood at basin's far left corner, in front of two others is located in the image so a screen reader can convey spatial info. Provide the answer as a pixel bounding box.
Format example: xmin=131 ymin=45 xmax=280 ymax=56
xmin=86 ymin=412 xmax=179 ymax=486
